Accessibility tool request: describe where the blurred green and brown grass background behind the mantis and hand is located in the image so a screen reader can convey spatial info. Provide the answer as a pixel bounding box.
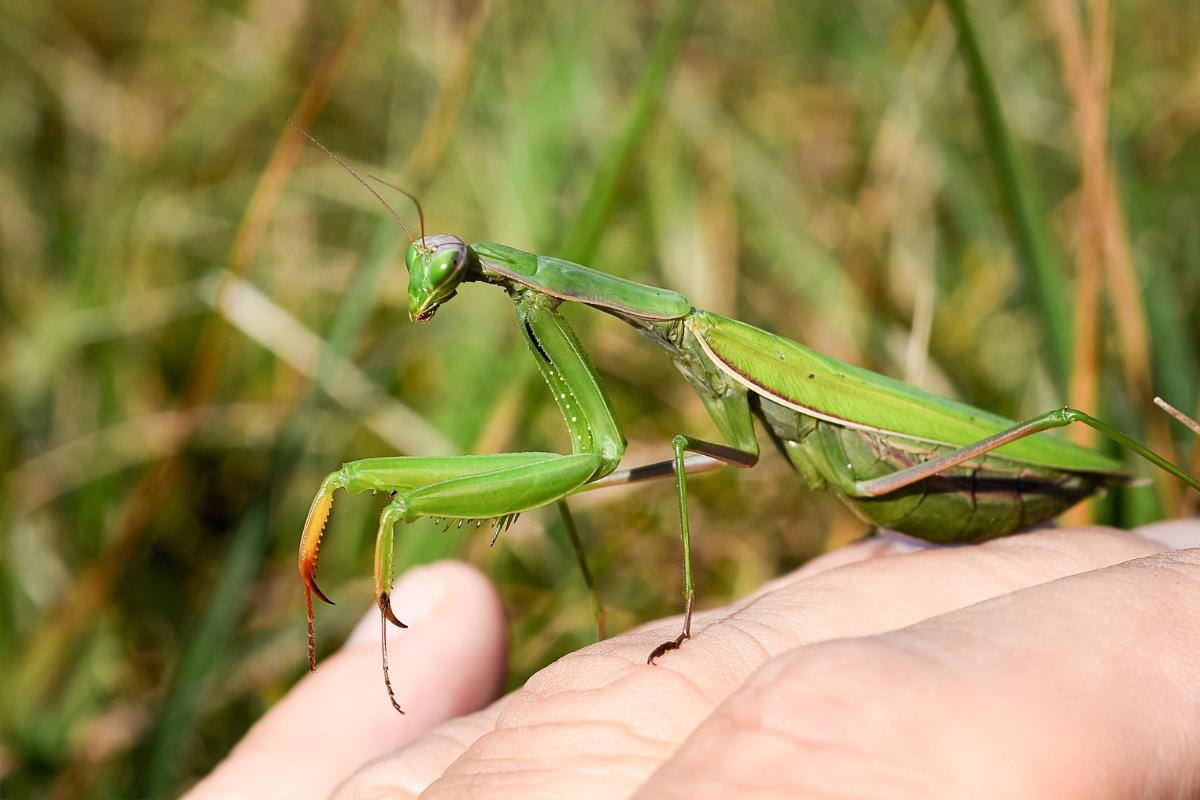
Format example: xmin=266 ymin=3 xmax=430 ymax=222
xmin=0 ymin=0 xmax=1200 ymax=796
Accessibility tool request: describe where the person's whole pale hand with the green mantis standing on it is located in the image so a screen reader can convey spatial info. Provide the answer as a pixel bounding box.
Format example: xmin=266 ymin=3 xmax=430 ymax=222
xmin=188 ymin=521 xmax=1200 ymax=800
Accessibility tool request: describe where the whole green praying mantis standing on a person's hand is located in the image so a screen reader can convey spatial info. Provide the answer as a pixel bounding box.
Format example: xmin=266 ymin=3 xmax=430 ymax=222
xmin=296 ymin=126 xmax=1200 ymax=712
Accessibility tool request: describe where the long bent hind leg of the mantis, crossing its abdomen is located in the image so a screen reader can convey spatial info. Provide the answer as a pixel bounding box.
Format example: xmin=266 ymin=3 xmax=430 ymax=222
xmin=851 ymin=407 xmax=1200 ymax=498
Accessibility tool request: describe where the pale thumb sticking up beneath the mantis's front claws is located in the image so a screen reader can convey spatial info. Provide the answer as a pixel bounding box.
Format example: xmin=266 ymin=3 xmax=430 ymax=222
xmin=186 ymin=561 xmax=508 ymax=800
